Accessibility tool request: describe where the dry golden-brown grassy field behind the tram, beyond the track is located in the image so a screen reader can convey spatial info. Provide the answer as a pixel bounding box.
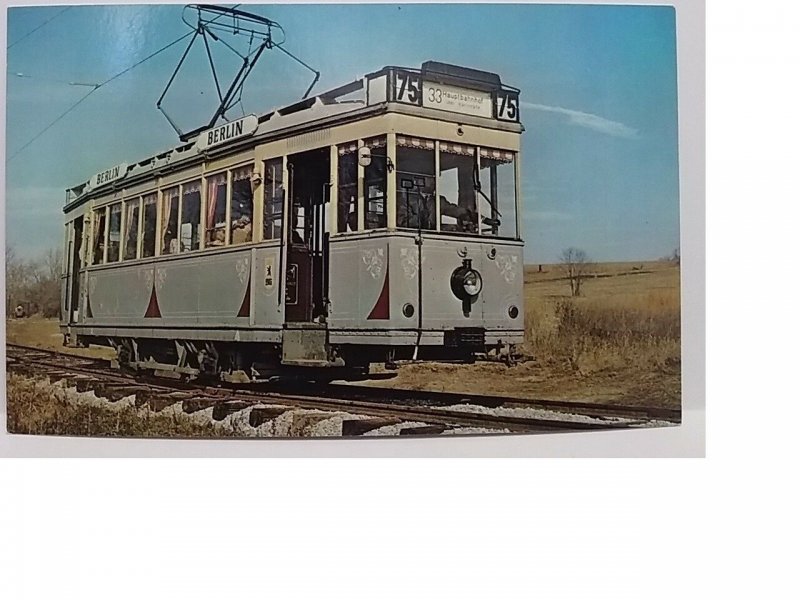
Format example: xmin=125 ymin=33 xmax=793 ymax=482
xmin=6 ymin=262 xmax=681 ymax=407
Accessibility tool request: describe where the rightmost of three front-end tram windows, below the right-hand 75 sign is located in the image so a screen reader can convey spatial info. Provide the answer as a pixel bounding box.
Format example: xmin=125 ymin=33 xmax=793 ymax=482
xmin=478 ymin=148 xmax=517 ymax=238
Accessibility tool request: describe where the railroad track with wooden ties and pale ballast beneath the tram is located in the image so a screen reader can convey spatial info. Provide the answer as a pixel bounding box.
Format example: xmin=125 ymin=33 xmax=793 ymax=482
xmin=6 ymin=344 xmax=680 ymax=436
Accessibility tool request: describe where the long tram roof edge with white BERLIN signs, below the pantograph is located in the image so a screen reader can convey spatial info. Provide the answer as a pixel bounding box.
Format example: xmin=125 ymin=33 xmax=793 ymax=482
xmin=64 ymin=61 xmax=519 ymax=212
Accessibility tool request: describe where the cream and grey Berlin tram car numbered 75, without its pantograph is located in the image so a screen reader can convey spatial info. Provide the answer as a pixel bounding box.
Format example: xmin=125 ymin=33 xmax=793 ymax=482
xmin=61 ymin=62 xmax=524 ymax=378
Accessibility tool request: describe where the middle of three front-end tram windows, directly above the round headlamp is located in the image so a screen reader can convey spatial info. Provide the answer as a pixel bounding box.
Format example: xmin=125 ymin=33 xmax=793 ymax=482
xmin=439 ymin=142 xmax=478 ymax=234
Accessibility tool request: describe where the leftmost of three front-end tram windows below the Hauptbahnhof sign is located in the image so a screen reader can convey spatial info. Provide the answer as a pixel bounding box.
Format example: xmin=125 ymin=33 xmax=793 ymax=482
xmin=396 ymin=136 xmax=436 ymax=230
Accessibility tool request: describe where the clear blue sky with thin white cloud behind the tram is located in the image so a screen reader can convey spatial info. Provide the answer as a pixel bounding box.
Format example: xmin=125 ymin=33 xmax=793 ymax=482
xmin=5 ymin=4 xmax=679 ymax=263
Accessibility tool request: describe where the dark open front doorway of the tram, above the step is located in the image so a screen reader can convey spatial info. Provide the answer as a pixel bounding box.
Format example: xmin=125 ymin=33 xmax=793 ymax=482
xmin=285 ymin=148 xmax=330 ymax=323
